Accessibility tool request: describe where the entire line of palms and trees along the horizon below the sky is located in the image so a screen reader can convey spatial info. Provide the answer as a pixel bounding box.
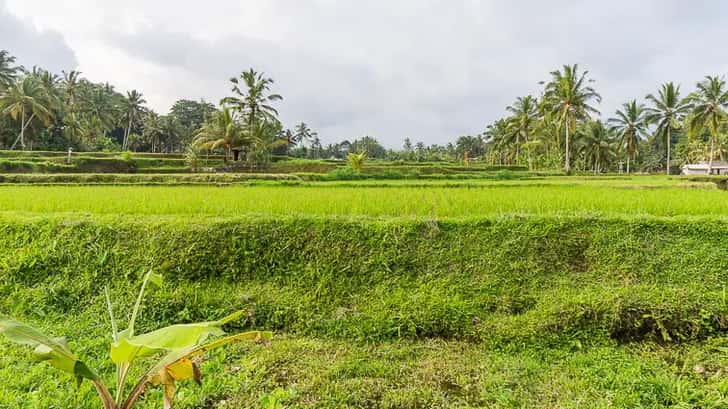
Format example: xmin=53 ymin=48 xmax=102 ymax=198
xmin=0 ymin=50 xmax=728 ymax=173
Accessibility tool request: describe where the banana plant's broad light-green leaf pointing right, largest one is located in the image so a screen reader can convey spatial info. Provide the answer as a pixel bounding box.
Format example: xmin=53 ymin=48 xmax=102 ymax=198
xmin=111 ymin=311 xmax=243 ymax=364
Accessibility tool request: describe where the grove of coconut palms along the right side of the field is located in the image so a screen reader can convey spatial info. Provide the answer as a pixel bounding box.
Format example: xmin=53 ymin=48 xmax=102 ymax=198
xmin=478 ymin=65 xmax=728 ymax=173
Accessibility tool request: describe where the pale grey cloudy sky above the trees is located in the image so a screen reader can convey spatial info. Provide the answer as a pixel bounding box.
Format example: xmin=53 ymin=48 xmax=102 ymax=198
xmin=0 ymin=0 xmax=728 ymax=147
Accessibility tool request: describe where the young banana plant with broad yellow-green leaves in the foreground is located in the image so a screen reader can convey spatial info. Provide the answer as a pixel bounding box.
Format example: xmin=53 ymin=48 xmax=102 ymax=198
xmin=0 ymin=270 xmax=272 ymax=409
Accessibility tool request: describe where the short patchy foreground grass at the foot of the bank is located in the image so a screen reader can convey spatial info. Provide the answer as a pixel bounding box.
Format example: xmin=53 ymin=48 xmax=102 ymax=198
xmin=5 ymin=332 xmax=728 ymax=409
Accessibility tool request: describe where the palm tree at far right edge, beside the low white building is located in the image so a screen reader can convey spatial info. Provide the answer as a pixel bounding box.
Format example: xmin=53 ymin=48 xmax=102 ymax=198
xmin=690 ymin=76 xmax=728 ymax=175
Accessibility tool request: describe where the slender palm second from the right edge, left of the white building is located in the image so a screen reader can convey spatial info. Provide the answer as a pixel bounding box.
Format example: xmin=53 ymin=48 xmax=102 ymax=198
xmin=645 ymin=82 xmax=690 ymax=175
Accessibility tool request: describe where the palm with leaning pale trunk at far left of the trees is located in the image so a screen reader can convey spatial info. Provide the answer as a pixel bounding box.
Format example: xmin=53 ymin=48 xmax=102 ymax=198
xmin=0 ymin=75 xmax=51 ymax=149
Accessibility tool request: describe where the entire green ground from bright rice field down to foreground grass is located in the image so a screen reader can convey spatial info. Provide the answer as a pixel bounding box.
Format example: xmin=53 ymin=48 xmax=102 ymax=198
xmin=0 ymin=182 xmax=728 ymax=408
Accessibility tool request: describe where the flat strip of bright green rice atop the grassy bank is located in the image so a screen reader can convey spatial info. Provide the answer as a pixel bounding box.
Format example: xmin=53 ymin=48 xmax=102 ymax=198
xmin=0 ymin=183 xmax=728 ymax=217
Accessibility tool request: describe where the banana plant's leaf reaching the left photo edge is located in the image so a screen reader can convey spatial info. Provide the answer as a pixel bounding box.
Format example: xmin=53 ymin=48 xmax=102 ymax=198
xmin=0 ymin=316 xmax=99 ymax=381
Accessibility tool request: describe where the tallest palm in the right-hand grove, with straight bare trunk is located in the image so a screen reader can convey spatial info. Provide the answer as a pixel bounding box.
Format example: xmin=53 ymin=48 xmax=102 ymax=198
xmin=544 ymin=64 xmax=602 ymax=172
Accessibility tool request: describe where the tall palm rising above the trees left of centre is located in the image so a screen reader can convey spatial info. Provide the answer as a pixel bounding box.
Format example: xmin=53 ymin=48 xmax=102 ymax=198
xmin=221 ymin=68 xmax=283 ymax=132
